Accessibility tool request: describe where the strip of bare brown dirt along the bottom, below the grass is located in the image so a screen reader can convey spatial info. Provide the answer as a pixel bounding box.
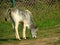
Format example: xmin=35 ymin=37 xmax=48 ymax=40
xmin=0 ymin=37 xmax=60 ymax=45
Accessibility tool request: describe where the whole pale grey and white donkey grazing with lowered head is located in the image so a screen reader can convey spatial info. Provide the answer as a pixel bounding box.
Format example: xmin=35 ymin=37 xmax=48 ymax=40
xmin=5 ymin=8 xmax=37 ymax=40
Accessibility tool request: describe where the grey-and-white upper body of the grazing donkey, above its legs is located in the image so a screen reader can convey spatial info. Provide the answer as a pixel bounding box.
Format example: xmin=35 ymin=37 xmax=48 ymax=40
xmin=11 ymin=9 xmax=31 ymax=22
